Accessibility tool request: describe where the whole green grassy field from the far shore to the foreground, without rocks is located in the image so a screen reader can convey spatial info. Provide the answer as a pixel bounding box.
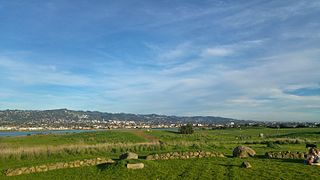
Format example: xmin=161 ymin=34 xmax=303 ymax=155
xmin=0 ymin=128 xmax=320 ymax=179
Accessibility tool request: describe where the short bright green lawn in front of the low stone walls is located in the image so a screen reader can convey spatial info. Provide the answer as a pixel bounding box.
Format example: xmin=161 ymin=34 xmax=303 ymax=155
xmin=6 ymin=158 xmax=320 ymax=179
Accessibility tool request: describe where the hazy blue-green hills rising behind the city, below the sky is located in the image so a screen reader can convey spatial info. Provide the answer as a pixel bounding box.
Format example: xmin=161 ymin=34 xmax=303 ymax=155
xmin=0 ymin=109 xmax=254 ymax=124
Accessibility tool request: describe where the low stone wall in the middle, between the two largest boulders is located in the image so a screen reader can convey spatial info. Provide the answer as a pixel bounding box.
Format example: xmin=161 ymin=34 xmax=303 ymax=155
xmin=146 ymin=151 xmax=224 ymax=160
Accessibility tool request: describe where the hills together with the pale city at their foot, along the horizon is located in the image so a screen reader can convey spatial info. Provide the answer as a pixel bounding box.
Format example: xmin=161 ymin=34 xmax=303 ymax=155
xmin=0 ymin=109 xmax=320 ymax=131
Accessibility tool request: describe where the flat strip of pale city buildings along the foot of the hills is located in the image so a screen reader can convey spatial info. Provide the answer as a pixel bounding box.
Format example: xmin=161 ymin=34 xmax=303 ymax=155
xmin=0 ymin=120 xmax=320 ymax=131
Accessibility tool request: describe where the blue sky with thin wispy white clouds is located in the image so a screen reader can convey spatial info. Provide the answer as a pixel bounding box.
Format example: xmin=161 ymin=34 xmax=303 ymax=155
xmin=0 ymin=0 xmax=320 ymax=122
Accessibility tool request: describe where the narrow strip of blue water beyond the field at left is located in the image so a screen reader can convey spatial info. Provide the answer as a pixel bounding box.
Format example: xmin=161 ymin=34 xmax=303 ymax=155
xmin=0 ymin=130 xmax=97 ymax=137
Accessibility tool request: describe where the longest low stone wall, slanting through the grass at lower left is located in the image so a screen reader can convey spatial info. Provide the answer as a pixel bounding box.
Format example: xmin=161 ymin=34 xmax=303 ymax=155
xmin=5 ymin=158 xmax=114 ymax=176
